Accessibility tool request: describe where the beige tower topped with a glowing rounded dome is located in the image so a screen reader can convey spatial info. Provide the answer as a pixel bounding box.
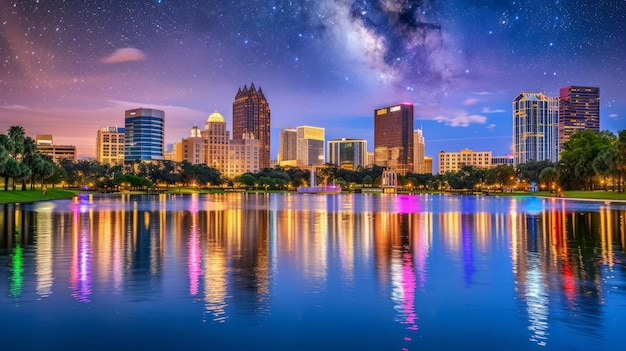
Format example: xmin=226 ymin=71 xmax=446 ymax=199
xmin=202 ymin=111 xmax=230 ymax=173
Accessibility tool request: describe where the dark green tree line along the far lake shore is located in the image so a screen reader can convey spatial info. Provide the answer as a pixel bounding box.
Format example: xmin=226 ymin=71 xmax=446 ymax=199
xmin=0 ymin=126 xmax=626 ymax=191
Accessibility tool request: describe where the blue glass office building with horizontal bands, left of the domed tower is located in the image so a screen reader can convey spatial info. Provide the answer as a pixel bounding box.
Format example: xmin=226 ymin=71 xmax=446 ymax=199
xmin=124 ymin=108 xmax=165 ymax=161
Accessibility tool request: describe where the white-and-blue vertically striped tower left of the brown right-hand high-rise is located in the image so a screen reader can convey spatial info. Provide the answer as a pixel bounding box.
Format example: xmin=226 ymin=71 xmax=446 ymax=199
xmin=513 ymin=93 xmax=559 ymax=165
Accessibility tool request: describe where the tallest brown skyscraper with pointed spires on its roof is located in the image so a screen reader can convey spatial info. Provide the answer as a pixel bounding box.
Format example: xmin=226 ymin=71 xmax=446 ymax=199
xmin=233 ymin=83 xmax=270 ymax=168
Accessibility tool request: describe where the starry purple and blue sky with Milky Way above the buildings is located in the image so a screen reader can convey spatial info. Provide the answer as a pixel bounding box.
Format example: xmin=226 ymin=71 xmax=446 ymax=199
xmin=0 ymin=0 xmax=626 ymax=164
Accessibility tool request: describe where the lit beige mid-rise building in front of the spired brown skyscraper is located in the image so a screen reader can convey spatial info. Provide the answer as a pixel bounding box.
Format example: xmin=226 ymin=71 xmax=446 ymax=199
xmin=223 ymin=133 xmax=261 ymax=178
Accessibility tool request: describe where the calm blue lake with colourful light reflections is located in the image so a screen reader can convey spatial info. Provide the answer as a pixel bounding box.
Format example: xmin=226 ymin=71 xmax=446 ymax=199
xmin=0 ymin=194 xmax=626 ymax=350
